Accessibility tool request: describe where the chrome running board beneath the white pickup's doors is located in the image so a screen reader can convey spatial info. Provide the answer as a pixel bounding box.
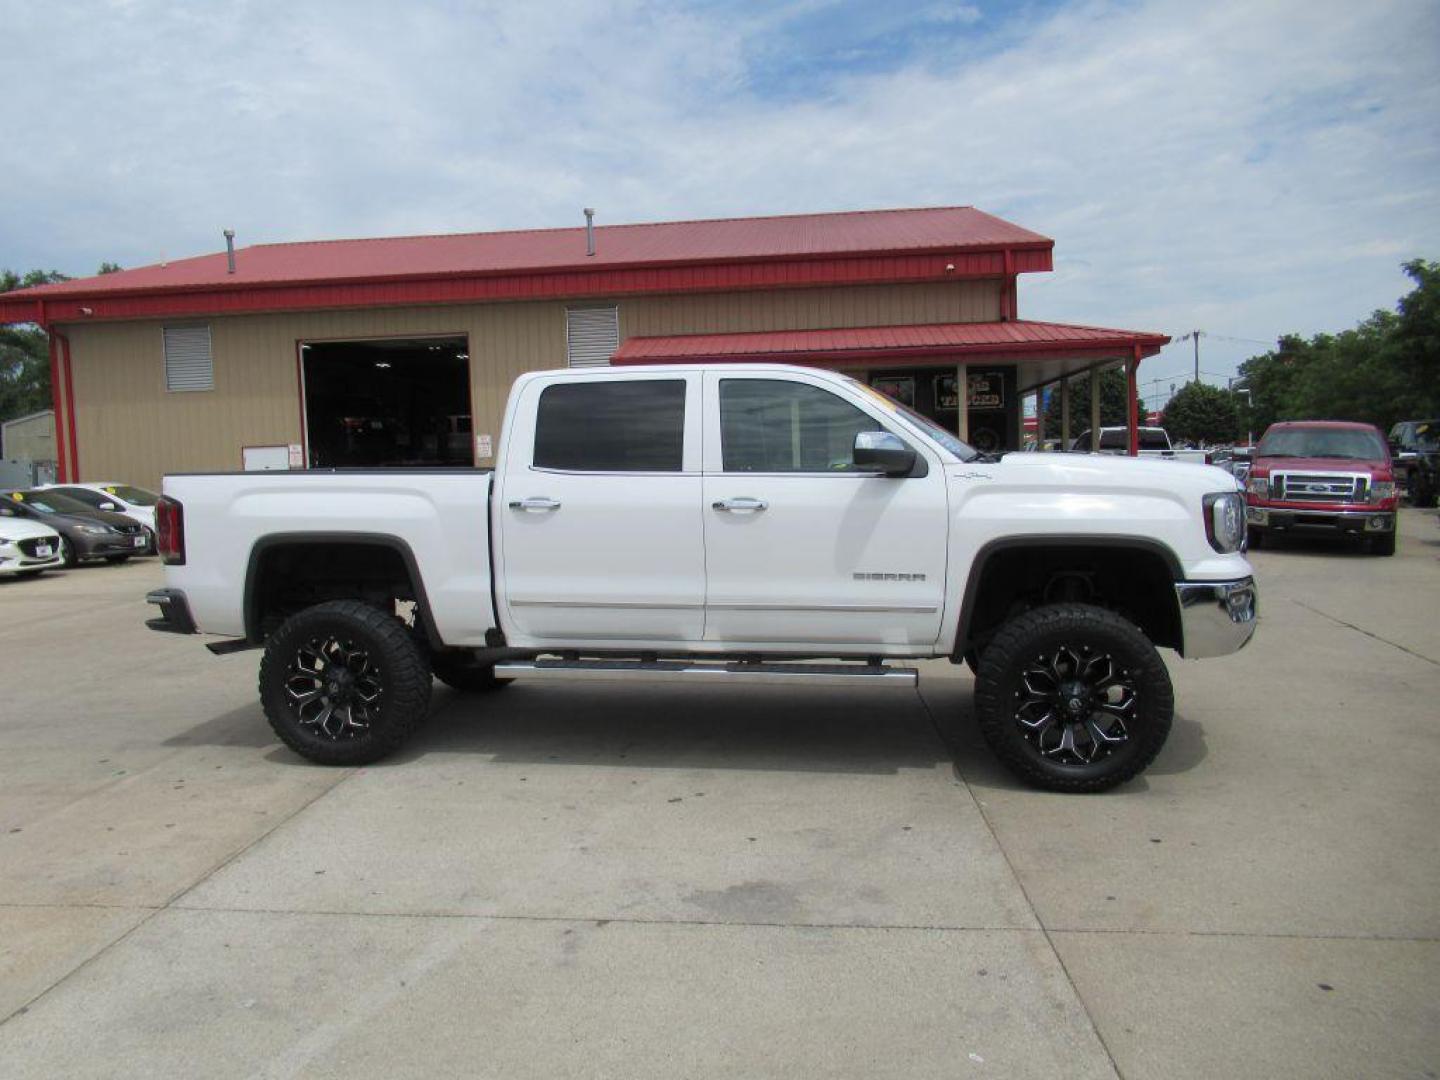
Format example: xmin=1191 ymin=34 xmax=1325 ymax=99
xmin=495 ymin=658 xmax=920 ymax=687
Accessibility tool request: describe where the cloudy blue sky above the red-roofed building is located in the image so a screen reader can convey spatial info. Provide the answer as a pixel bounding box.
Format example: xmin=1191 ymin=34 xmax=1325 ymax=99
xmin=0 ymin=0 xmax=1440 ymax=400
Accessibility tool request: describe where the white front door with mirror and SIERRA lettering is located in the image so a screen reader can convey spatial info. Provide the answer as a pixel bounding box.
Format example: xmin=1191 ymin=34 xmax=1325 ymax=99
xmin=704 ymin=372 xmax=948 ymax=654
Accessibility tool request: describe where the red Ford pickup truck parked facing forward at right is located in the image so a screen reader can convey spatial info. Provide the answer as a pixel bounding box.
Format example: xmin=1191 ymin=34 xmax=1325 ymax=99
xmin=1246 ymin=420 xmax=1397 ymax=554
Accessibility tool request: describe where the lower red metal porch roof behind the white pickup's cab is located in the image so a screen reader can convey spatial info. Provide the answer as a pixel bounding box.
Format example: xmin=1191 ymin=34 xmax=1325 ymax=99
xmin=613 ymin=320 xmax=1169 ymax=366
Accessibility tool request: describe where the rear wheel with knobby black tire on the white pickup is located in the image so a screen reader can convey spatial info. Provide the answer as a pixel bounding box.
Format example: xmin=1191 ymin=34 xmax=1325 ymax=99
xmin=259 ymin=600 xmax=431 ymax=765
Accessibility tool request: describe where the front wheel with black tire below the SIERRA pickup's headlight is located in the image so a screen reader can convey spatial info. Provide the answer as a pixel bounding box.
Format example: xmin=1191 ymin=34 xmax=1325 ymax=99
xmin=975 ymin=603 xmax=1175 ymax=792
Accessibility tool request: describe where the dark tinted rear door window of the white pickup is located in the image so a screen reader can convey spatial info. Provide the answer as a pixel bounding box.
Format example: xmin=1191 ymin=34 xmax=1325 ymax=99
xmin=534 ymin=379 xmax=685 ymax=472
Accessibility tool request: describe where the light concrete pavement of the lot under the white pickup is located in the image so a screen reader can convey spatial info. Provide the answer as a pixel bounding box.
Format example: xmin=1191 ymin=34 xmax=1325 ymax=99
xmin=0 ymin=511 xmax=1440 ymax=1077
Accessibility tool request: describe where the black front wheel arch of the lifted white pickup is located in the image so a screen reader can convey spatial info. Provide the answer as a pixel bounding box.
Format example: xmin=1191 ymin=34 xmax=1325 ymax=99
xmin=952 ymin=533 xmax=1184 ymax=660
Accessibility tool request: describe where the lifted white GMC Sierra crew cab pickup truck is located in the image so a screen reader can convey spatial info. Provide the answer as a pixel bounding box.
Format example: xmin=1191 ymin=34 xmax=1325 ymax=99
xmin=147 ymin=364 xmax=1256 ymax=791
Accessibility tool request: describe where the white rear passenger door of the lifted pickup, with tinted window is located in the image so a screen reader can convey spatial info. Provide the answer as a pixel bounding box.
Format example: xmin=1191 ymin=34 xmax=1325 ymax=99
xmin=492 ymin=370 xmax=706 ymax=645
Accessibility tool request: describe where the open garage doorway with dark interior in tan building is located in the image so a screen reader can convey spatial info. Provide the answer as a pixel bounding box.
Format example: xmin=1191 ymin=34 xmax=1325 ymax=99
xmin=300 ymin=337 xmax=475 ymax=468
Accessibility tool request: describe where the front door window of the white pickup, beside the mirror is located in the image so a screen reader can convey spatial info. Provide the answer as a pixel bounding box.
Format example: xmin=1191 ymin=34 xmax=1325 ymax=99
xmin=720 ymin=379 xmax=884 ymax=472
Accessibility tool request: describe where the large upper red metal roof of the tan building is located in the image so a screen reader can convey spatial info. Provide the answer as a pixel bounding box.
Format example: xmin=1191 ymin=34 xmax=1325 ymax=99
xmin=0 ymin=206 xmax=1054 ymax=321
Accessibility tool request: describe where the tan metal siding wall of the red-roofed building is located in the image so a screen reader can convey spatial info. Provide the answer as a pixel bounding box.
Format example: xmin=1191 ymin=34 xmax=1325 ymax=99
xmin=66 ymin=281 xmax=999 ymax=487
